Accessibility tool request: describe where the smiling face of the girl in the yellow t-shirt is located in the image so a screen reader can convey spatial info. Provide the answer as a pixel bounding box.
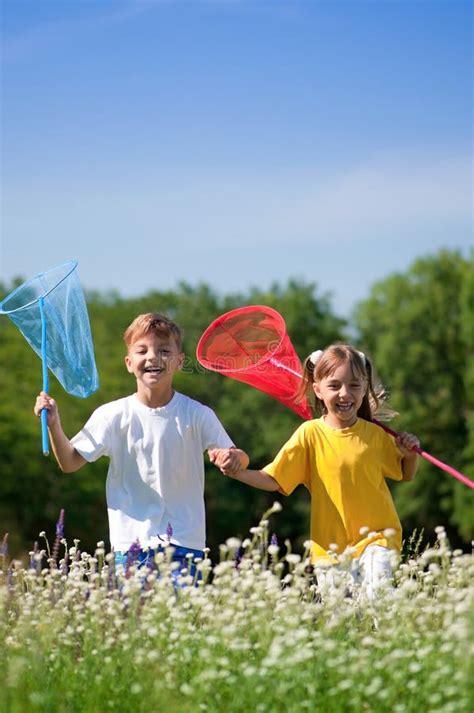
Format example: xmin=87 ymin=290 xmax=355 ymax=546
xmin=313 ymin=361 xmax=367 ymax=428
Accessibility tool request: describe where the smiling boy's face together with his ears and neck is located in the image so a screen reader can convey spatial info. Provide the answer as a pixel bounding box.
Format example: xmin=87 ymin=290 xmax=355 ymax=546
xmin=125 ymin=332 xmax=183 ymax=408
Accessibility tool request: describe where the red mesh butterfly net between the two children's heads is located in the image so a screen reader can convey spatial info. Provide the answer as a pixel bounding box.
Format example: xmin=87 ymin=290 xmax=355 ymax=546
xmin=196 ymin=305 xmax=312 ymax=419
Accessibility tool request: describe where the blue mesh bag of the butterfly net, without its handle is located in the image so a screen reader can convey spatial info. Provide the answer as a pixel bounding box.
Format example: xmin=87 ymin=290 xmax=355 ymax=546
xmin=0 ymin=260 xmax=99 ymax=398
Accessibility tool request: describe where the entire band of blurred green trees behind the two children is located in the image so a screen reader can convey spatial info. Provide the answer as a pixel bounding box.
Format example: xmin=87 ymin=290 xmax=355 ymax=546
xmin=0 ymin=250 xmax=474 ymax=556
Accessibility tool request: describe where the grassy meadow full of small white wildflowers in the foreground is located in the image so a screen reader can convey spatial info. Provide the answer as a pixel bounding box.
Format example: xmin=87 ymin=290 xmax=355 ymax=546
xmin=0 ymin=504 xmax=474 ymax=713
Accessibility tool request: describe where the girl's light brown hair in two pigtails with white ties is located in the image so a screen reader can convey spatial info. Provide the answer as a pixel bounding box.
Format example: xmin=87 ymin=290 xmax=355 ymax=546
xmin=297 ymin=344 xmax=396 ymax=421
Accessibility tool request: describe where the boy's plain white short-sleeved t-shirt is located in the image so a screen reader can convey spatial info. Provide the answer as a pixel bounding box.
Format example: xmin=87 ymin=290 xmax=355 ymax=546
xmin=71 ymin=393 xmax=234 ymax=552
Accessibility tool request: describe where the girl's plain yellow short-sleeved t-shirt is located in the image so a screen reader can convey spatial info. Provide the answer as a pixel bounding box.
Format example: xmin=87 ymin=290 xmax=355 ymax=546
xmin=264 ymin=418 xmax=402 ymax=563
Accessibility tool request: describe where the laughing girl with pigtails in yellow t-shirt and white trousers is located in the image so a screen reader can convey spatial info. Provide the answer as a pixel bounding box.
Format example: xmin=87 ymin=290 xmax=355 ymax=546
xmin=210 ymin=344 xmax=419 ymax=598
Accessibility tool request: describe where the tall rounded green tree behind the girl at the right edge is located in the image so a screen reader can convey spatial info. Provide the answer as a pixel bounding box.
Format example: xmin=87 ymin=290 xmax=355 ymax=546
xmin=355 ymin=250 xmax=474 ymax=542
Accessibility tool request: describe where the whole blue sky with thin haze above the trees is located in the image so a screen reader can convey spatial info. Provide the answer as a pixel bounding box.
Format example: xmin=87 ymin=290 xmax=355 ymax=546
xmin=0 ymin=0 xmax=473 ymax=314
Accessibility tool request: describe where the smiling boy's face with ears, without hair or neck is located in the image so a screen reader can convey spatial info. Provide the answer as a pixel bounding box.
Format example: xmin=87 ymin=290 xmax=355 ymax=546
xmin=125 ymin=332 xmax=184 ymax=389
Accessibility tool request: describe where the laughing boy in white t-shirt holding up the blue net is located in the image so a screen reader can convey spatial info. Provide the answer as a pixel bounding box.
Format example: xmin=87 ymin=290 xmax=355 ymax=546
xmin=34 ymin=313 xmax=249 ymax=565
